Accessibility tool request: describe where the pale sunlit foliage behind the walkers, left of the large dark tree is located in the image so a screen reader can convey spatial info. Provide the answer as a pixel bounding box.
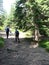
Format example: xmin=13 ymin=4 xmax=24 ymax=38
xmin=4 ymin=4 xmax=16 ymax=28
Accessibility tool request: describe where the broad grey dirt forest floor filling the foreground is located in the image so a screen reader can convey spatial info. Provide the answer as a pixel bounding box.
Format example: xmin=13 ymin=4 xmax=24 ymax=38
xmin=0 ymin=31 xmax=49 ymax=65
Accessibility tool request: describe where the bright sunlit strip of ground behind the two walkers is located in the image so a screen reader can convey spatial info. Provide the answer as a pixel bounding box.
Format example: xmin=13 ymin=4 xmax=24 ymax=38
xmin=0 ymin=31 xmax=31 ymax=38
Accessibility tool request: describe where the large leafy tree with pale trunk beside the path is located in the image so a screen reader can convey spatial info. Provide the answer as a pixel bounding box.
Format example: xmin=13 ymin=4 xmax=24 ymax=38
xmin=15 ymin=0 xmax=49 ymax=41
